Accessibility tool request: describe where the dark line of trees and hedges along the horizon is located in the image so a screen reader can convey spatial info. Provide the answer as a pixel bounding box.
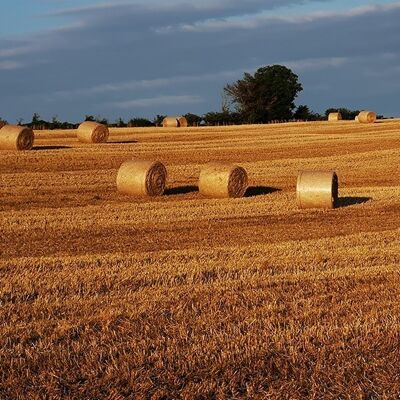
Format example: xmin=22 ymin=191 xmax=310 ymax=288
xmin=0 ymin=65 xmax=382 ymax=129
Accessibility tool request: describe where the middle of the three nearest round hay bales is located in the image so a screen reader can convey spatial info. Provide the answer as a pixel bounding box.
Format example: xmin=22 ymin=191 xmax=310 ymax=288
xmin=199 ymin=163 xmax=248 ymax=198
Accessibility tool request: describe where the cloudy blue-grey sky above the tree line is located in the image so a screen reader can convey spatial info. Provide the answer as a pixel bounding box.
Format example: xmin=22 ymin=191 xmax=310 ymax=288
xmin=0 ymin=0 xmax=400 ymax=123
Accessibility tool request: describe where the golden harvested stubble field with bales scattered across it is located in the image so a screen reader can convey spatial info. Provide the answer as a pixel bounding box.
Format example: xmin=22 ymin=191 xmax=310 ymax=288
xmin=0 ymin=121 xmax=400 ymax=400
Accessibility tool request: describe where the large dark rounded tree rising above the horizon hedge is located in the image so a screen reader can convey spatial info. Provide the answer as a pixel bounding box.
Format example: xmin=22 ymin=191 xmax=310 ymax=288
xmin=224 ymin=65 xmax=303 ymax=123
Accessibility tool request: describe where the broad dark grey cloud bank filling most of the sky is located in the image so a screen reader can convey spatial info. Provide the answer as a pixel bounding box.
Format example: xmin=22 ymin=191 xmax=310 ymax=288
xmin=0 ymin=3 xmax=400 ymax=120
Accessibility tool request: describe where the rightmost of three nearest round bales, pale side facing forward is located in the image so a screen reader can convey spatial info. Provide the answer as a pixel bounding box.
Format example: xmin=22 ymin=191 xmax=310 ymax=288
xmin=297 ymin=171 xmax=339 ymax=209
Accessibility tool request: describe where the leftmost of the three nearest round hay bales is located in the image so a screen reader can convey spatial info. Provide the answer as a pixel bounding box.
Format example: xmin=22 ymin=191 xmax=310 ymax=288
xmin=117 ymin=160 xmax=167 ymax=196
